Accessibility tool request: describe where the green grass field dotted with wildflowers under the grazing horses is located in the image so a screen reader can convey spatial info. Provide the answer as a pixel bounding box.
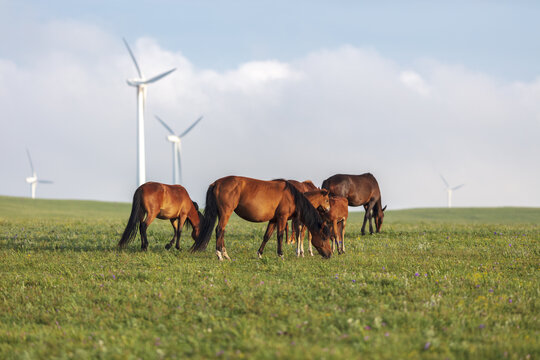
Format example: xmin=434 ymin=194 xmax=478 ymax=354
xmin=0 ymin=197 xmax=540 ymax=359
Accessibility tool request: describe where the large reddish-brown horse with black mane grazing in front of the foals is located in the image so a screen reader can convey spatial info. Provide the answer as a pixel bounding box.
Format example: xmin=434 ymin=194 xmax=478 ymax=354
xmin=191 ymin=176 xmax=332 ymax=260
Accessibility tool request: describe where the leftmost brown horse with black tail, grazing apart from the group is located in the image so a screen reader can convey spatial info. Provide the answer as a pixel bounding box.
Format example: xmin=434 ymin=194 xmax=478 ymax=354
xmin=118 ymin=182 xmax=203 ymax=250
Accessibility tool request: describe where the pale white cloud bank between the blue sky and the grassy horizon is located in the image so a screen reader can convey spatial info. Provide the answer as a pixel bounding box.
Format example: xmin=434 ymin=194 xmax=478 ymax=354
xmin=0 ymin=22 xmax=540 ymax=208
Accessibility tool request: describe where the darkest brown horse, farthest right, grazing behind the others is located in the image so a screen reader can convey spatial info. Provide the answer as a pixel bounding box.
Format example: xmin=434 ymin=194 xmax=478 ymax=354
xmin=322 ymin=173 xmax=386 ymax=235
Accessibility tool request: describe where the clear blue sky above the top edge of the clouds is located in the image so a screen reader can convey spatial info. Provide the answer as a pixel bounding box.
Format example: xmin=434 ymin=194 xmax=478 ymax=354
xmin=4 ymin=0 xmax=540 ymax=80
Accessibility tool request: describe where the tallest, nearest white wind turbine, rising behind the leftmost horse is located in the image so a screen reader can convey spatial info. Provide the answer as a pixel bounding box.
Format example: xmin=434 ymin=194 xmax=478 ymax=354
xmin=122 ymin=39 xmax=176 ymax=186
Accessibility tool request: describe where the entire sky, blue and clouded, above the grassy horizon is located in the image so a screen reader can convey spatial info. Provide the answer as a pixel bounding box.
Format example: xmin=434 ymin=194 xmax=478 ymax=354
xmin=0 ymin=0 xmax=540 ymax=209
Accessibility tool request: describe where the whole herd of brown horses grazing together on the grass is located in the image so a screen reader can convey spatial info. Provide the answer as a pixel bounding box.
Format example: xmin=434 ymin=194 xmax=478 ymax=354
xmin=118 ymin=173 xmax=386 ymax=260
